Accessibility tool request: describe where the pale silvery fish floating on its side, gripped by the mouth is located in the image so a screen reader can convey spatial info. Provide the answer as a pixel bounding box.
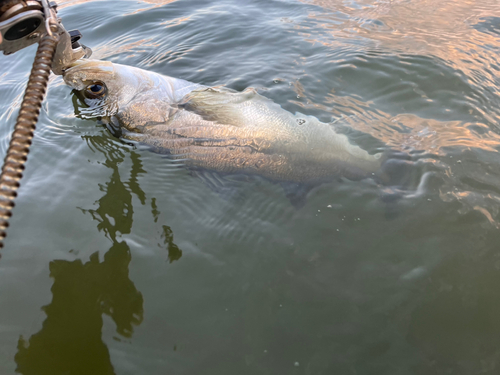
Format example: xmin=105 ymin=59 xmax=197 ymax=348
xmin=63 ymin=60 xmax=383 ymax=185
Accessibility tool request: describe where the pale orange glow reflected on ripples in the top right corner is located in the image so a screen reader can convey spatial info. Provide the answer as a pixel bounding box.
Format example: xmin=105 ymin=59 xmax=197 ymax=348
xmin=296 ymin=0 xmax=500 ymax=123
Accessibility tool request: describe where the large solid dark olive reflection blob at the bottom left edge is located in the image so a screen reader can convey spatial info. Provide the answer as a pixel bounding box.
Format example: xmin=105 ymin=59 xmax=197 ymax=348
xmin=15 ymin=242 xmax=143 ymax=375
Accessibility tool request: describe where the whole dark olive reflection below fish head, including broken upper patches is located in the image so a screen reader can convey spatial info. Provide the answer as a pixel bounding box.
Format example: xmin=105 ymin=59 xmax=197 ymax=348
xmin=15 ymin=131 xmax=182 ymax=375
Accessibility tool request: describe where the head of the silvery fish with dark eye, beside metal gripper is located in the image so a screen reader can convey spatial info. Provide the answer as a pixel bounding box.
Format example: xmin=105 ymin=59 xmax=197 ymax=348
xmin=63 ymin=60 xmax=180 ymax=132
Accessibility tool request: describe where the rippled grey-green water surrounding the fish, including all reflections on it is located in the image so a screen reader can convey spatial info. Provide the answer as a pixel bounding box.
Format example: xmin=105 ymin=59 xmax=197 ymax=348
xmin=0 ymin=0 xmax=500 ymax=375
